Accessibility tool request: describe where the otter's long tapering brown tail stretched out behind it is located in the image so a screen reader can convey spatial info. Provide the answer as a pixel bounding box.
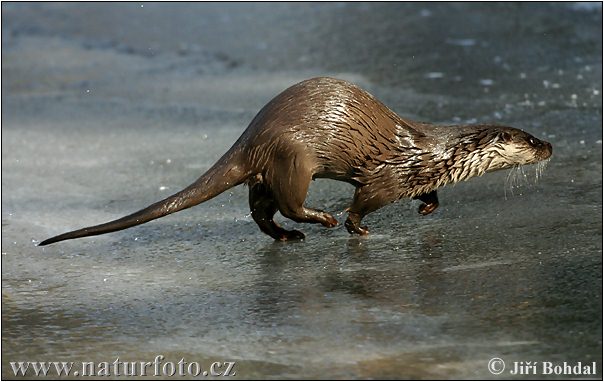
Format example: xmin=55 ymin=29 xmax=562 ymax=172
xmin=38 ymin=149 xmax=249 ymax=245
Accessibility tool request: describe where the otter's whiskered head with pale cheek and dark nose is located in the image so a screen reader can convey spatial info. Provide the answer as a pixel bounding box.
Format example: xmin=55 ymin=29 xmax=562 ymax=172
xmin=482 ymin=126 xmax=552 ymax=171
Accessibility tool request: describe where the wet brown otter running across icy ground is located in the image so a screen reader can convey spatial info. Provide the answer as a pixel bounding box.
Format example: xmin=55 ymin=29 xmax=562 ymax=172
xmin=39 ymin=77 xmax=552 ymax=245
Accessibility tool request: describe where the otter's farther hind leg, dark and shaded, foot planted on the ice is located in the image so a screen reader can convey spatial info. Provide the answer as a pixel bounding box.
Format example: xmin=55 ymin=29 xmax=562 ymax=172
xmin=249 ymin=183 xmax=304 ymax=241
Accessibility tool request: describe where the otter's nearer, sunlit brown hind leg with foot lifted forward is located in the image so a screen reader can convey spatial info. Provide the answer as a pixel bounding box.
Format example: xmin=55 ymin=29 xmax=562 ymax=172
xmin=270 ymin=158 xmax=338 ymax=228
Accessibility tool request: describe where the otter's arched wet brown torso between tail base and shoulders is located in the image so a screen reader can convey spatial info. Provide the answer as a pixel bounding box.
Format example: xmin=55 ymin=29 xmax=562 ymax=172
xmin=242 ymin=77 xmax=407 ymax=177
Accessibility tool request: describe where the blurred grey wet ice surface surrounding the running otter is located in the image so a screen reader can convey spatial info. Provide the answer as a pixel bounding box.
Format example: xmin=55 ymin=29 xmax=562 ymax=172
xmin=2 ymin=2 xmax=602 ymax=379
